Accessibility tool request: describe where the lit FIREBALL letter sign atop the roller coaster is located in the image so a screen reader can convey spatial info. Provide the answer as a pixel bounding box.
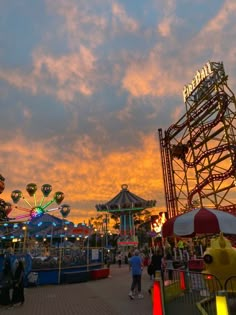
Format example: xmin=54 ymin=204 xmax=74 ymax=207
xmin=183 ymin=62 xmax=214 ymax=102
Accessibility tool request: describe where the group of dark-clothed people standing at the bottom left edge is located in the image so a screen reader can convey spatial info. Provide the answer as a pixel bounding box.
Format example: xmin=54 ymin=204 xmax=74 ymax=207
xmin=0 ymin=259 xmax=25 ymax=308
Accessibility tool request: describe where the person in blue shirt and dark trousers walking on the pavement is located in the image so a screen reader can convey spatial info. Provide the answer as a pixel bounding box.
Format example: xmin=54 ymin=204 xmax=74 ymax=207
xmin=129 ymin=249 xmax=143 ymax=300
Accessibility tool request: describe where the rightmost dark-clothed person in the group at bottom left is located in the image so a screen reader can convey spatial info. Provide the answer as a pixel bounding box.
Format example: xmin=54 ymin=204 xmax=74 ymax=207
xmin=12 ymin=260 xmax=25 ymax=305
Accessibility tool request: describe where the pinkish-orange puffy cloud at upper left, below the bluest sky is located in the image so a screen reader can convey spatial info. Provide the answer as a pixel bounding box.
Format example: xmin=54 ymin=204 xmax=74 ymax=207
xmin=0 ymin=46 xmax=96 ymax=102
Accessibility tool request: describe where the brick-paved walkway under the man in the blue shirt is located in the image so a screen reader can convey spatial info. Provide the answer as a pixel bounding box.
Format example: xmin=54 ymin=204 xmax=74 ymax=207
xmin=0 ymin=265 xmax=152 ymax=315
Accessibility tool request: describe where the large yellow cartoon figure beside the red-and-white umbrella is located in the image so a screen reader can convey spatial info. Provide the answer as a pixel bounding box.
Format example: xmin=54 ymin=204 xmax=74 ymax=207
xmin=203 ymin=234 xmax=236 ymax=291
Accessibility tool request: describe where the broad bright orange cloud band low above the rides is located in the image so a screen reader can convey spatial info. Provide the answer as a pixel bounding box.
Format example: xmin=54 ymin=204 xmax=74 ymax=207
xmin=0 ymin=131 xmax=165 ymax=222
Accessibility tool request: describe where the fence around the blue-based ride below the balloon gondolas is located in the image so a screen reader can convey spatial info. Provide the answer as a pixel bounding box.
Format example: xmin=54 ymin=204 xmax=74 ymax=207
xmin=0 ymin=246 xmax=108 ymax=284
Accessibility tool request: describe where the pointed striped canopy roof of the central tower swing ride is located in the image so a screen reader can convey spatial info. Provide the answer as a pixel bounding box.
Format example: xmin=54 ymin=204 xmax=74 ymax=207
xmin=96 ymin=184 xmax=156 ymax=213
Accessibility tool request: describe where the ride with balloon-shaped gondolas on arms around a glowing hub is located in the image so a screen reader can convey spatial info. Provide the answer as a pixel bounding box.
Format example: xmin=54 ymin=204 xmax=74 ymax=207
xmin=0 ymin=183 xmax=70 ymax=221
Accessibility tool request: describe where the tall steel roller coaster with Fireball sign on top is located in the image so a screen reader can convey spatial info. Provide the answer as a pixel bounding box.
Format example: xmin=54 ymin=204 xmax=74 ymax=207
xmin=158 ymin=62 xmax=236 ymax=218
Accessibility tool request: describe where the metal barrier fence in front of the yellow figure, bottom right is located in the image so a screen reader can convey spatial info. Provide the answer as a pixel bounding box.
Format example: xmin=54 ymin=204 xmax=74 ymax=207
xmin=159 ymin=270 xmax=236 ymax=315
